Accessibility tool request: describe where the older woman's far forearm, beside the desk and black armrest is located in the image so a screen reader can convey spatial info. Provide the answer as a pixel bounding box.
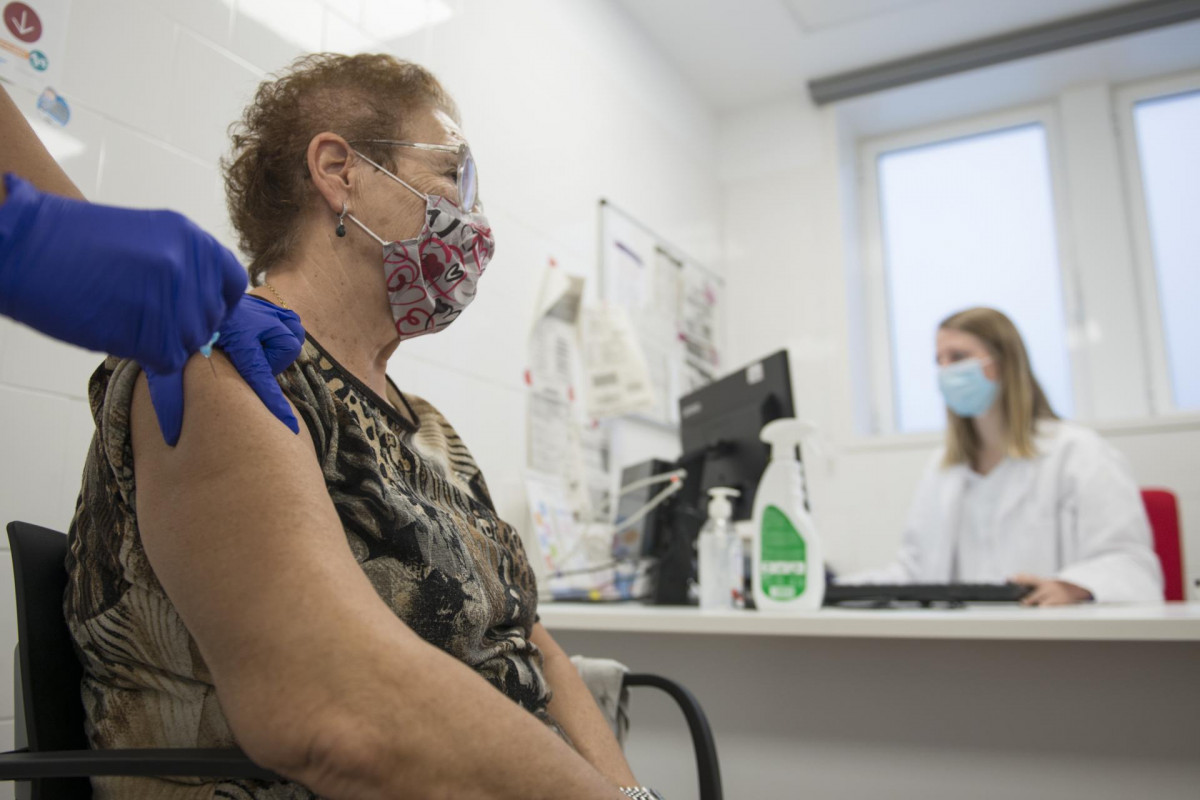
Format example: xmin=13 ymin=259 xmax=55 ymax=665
xmin=533 ymin=624 xmax=637 ymax=786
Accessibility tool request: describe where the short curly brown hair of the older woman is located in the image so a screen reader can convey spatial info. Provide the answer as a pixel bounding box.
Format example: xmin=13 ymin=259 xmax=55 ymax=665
xmin=221 ymin=53 xmax=458 ymax=284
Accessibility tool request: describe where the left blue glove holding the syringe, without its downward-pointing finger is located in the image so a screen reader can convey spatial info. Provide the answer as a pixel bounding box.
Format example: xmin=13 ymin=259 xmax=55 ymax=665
xmin=0 ymin=174 xmax=246 ymax=372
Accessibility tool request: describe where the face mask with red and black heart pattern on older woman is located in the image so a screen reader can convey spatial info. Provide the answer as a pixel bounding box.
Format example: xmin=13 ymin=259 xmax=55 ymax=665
xmin=346 ymin=151 xmax=496 ymax=339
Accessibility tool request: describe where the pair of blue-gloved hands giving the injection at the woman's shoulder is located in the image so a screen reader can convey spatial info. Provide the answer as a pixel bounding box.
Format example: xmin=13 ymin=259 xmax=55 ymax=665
xmin=0 ymin=174 xmax=305 ymax=445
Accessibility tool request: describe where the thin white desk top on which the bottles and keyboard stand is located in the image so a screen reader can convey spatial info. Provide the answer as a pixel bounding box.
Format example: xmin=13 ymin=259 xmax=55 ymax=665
xmin=538 ymin=602 xmax=1200 ymax=642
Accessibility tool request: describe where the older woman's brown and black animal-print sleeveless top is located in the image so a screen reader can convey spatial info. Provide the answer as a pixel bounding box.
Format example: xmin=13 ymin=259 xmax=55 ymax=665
xmin=64 ymin=337 xmax=549 ymax=800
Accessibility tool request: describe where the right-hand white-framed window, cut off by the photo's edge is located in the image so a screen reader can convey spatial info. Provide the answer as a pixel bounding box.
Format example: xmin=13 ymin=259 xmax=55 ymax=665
xmin=1118 ymin=82 xmax=1200 ymax=411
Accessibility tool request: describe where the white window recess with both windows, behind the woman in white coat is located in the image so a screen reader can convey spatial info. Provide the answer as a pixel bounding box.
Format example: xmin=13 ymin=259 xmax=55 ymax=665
xmin=838 ymin=50 xmax=1200 ymax=439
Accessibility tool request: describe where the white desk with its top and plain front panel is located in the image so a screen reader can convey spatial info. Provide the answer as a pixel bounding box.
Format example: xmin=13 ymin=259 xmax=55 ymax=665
xmin=549 ymin=603 xmax=1200 ymax=800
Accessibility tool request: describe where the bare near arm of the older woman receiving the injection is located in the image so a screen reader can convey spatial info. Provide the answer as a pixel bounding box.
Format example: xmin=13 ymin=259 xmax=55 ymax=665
xmin=132 ymin=355 xmax=638 ymax=798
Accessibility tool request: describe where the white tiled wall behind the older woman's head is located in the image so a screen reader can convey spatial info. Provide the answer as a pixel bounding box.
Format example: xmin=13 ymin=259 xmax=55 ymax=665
xmin=0 ymin=0 xmax=720 ymax=782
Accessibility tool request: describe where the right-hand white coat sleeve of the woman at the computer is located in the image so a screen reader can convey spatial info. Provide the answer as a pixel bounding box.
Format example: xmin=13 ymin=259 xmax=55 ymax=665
xmin=1057 ymin=431 xmax=1163 ymax=603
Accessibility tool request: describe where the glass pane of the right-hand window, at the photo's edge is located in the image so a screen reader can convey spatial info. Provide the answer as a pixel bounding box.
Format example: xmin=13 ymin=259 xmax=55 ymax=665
xmin=1133 ymin=91 xmax=1200 ymax=409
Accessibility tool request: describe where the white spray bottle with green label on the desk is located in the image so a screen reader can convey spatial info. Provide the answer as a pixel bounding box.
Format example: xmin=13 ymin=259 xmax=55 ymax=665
xmin=754 ymin=419 xmax=824 ymax=613
